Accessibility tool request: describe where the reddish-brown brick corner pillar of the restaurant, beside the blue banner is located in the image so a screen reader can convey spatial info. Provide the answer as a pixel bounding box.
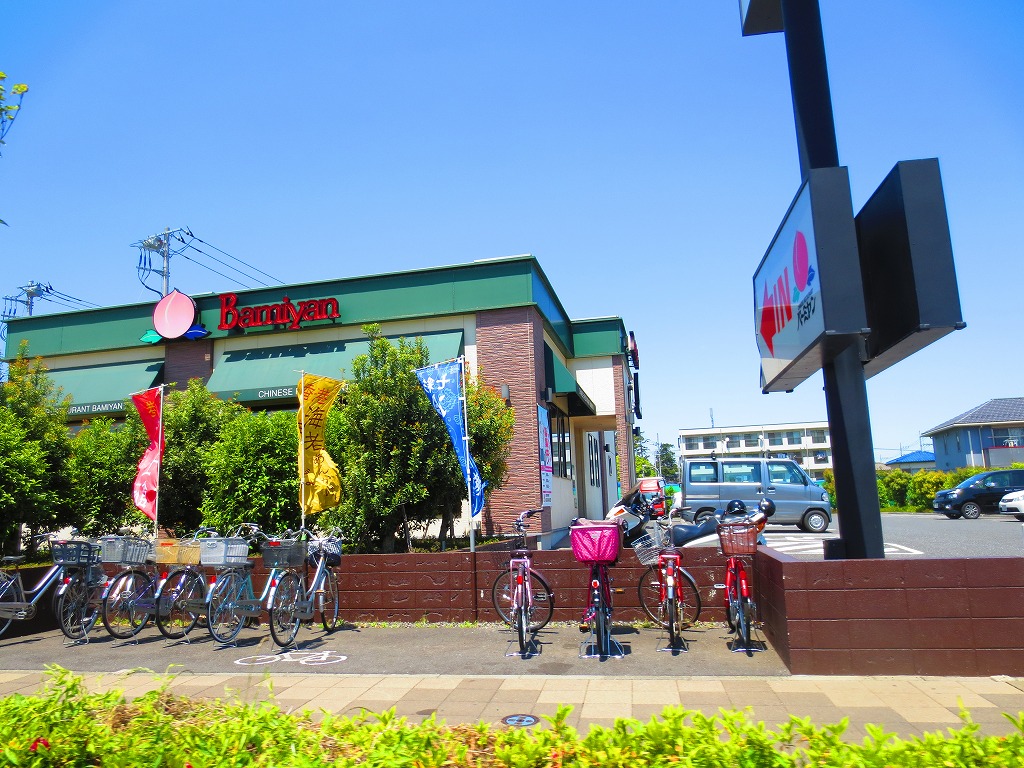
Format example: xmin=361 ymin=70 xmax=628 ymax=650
xmin=476 ymin=307 xmax=544 ymax=534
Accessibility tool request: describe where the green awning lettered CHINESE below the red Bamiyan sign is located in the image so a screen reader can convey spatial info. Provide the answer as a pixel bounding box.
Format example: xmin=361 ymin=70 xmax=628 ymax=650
xmin=207 ymin=331 xmax=463 ymax=402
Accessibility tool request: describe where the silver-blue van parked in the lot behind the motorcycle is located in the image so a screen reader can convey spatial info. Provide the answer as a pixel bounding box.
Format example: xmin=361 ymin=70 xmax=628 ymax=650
xmin=682 ymin=457 xmax=831 ymax=534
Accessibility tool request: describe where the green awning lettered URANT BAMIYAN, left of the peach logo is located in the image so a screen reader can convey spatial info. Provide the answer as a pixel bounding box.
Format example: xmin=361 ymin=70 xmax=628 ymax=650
xmin=47 ymin=360 xmax=164 ymax=419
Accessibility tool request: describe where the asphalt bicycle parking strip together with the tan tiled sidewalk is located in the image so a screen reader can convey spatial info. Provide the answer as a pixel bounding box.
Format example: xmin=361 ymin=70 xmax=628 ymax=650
xmin=0 ymin=626 xmax=1024 ymax=741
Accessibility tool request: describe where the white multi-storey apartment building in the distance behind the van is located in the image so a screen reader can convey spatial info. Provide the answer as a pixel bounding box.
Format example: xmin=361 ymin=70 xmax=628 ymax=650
xmin=677 ymin=421 xmax=833 ymax=480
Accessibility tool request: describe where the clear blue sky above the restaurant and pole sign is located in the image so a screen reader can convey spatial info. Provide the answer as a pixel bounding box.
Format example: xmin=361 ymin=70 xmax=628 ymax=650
xmin=0 ymin=0 xmax=1024 ymax=459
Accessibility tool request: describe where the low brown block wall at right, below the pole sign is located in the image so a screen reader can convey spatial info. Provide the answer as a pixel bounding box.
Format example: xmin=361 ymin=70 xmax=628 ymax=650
xmin=756 ymin=549 xmax=1024 ymax=677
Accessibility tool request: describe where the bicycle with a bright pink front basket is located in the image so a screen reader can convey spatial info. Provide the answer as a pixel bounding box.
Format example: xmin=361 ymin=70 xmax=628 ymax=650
xmin=569 ymin=518 xmax=625 ymax=658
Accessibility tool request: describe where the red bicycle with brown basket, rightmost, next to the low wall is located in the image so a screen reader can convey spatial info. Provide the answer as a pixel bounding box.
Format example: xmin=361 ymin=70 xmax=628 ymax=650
xmin=715 ymin=498 xmax=775 ymax=656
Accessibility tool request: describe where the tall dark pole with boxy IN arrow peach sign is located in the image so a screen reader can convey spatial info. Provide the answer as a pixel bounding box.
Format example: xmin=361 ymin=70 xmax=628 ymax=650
xmin=739 ymin=0 xmax=964 ymax=558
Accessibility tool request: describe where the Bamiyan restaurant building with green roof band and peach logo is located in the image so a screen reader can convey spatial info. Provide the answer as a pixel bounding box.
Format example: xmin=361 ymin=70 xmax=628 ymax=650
xmin=5 ymin=255 xmax=640 ymax=540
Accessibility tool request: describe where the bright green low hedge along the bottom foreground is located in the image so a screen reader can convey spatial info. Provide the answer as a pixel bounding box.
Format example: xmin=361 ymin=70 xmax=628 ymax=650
xmin=6 ymin=667 xmax=1024 ymax=768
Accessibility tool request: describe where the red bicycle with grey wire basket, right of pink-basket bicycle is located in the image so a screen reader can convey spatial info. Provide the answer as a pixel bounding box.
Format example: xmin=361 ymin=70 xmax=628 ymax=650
xmin=633 ymin=512 xmax=701 ymax=650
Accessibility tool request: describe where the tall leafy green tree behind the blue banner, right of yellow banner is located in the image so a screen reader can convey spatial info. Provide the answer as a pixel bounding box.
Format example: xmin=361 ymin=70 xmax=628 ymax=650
xmin=323 ymin=325 xmax=514 ymax=552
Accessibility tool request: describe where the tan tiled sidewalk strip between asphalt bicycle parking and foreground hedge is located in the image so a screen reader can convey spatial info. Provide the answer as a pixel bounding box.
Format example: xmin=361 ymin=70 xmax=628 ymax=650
xmin=0 ymin=671 xmax=1024 ymax=741
